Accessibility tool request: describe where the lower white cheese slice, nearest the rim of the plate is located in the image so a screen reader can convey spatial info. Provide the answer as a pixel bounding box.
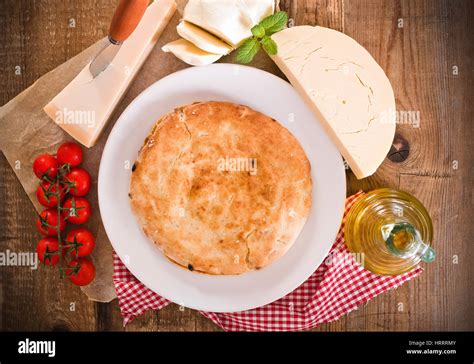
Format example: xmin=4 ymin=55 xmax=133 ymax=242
xmin=161 ymin=39 xmax=222 ymax=66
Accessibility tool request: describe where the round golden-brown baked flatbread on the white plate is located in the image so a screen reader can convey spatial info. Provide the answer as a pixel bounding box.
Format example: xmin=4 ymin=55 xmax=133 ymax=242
xmin=130 ymin=102 xmax=312 ymax=275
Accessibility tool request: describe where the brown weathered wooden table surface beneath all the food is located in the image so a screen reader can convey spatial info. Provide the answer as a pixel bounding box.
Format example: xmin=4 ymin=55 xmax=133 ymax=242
xmin=0 ymin=0 xmax=474 ymax=331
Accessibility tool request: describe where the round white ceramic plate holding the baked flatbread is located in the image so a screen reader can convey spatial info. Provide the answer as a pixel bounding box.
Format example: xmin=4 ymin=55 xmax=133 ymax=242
xmin=99 ymin=64 xmax=346 ymax=312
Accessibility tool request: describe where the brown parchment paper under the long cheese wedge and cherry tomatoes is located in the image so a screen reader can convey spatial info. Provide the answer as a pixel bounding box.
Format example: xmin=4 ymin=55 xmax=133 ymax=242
xmin=0 ymin=0 xmax=284 ymax=302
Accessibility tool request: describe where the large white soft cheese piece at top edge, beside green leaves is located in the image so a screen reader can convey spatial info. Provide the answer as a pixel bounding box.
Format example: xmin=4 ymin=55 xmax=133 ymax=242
xmin=183 ymin=0 xmax=275 ymax=47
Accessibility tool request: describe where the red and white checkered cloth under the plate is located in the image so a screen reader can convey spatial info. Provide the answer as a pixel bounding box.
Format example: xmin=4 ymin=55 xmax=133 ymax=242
xmin=114 ymin=192 xmax=423 ymax=331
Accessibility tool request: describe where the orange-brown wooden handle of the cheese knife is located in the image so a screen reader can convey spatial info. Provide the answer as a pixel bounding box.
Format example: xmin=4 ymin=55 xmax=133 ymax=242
xmin=109 ymin=0 xmax=150 ymax=43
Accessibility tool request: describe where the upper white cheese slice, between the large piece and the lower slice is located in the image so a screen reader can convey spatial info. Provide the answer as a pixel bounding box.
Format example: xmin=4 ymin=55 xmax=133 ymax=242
xmin=176 ymin=21 xmax=232 ymax=55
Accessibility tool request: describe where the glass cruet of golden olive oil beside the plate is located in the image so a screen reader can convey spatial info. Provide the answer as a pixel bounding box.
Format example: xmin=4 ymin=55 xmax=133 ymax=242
xmin=345 ymin=188 xmax=436 ymax=275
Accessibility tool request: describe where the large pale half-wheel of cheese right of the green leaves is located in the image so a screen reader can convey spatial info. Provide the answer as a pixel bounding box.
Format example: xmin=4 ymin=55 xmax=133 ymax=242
xmin=272 ymin=26 xmax=396 ymax=179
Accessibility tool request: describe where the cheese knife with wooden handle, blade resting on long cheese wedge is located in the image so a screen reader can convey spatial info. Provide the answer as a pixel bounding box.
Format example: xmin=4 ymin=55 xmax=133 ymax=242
xmin=89 ymin=0 xmax=150 ymax=78
